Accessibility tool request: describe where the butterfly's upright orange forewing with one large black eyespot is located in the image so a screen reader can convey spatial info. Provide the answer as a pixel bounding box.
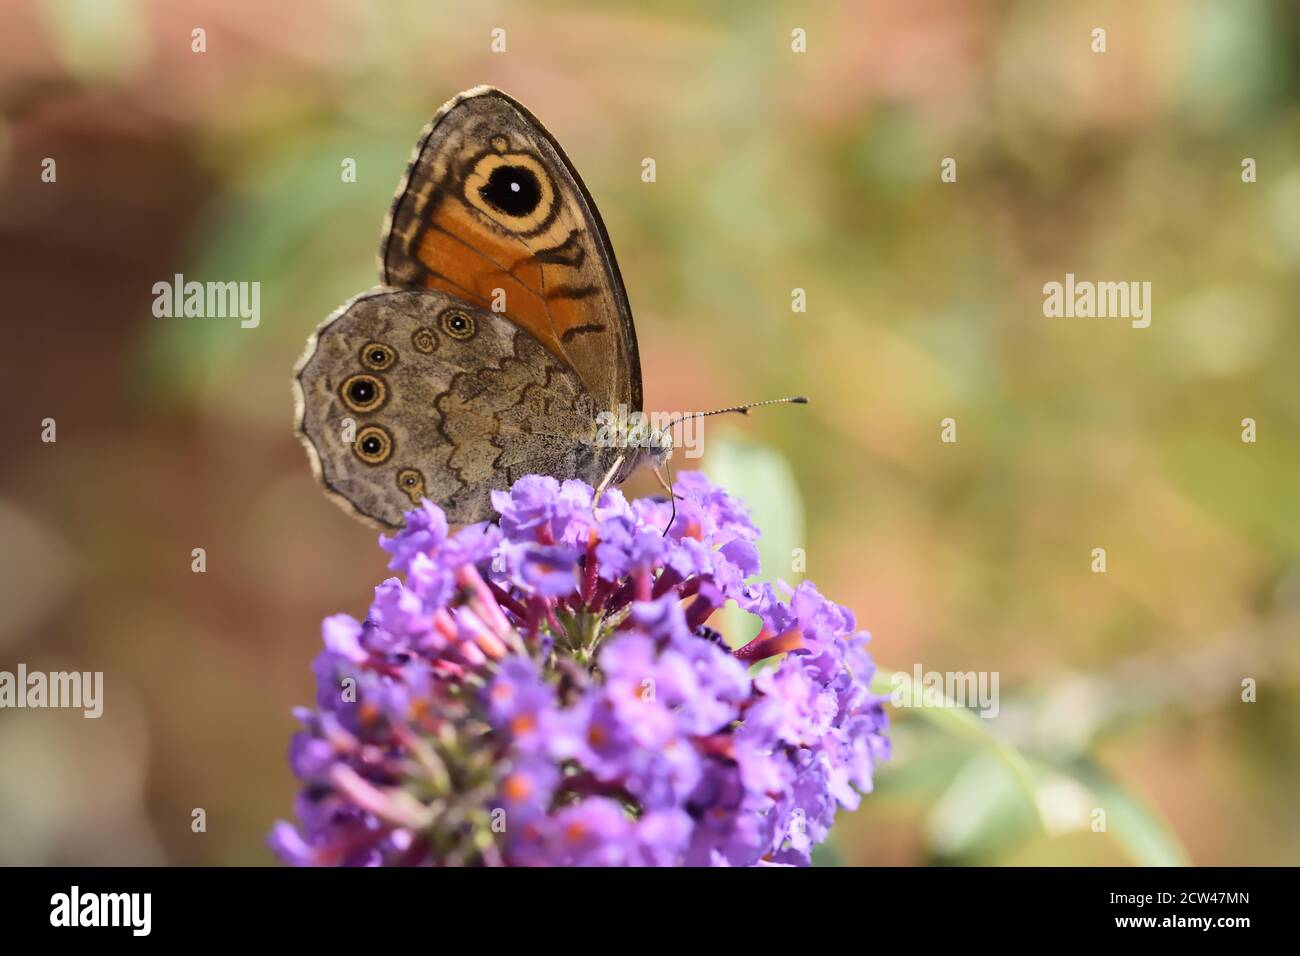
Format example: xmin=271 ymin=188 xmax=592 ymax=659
xmin=380 ymin=87 xmax=642 ymax=411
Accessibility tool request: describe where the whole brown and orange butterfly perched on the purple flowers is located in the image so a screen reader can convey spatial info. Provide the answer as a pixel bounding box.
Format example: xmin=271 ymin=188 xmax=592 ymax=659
xmin=294 ymin=86 xmax=801 ymax=528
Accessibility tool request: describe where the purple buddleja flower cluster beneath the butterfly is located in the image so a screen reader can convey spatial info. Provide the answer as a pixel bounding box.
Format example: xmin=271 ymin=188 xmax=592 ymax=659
xmin=270 ymin=473 xmax=888 ymax=866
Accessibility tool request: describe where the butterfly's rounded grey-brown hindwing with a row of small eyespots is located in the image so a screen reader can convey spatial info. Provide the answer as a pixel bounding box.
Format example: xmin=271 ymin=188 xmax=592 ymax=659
xmin=294 ymin=289 xmax=603 ymax=527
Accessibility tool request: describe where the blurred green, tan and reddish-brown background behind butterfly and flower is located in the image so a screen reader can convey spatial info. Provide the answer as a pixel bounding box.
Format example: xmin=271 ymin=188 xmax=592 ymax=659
xmin=0 ymin=0 xmax=1300 ymax=865
